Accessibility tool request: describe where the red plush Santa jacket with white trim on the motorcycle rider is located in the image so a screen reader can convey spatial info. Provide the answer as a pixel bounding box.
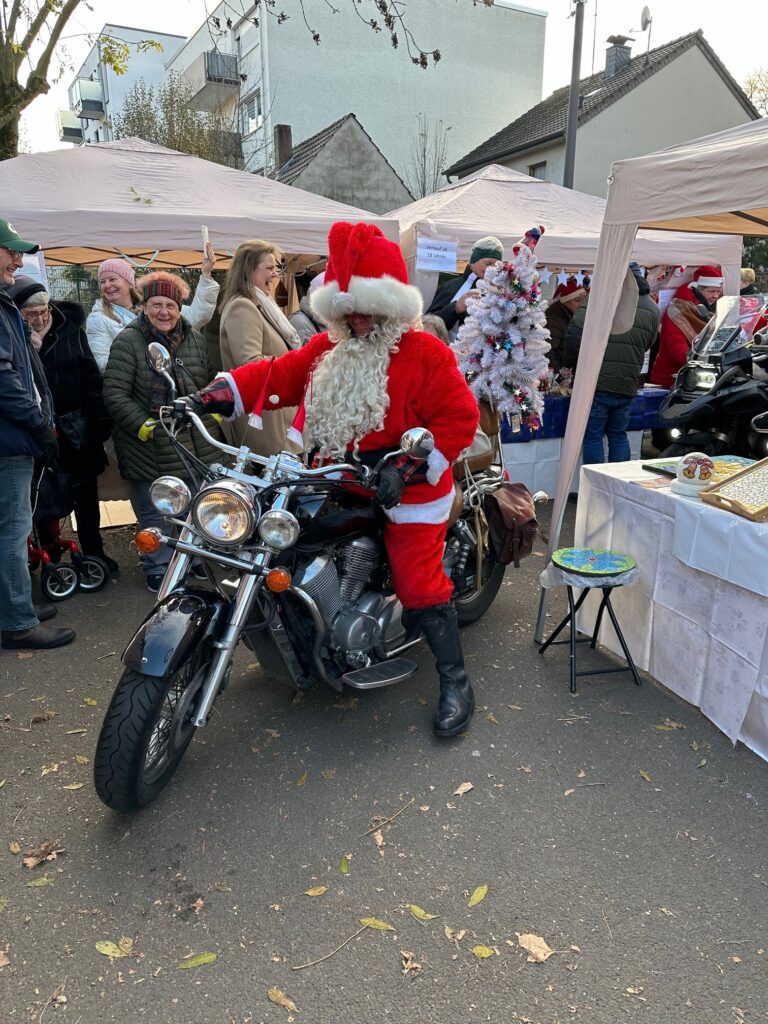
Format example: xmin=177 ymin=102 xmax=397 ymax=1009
xmin=226 ymin=331 xmax=479 ymax=523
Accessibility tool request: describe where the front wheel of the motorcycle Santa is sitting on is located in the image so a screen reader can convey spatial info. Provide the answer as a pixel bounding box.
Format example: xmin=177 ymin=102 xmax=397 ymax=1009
xmin=93 ymin=650 xmax=212 ymax=812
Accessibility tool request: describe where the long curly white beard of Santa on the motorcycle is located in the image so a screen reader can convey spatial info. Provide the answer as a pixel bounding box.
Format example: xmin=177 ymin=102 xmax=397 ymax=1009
xmin=305 ymin=321 xmax=403 ymax=459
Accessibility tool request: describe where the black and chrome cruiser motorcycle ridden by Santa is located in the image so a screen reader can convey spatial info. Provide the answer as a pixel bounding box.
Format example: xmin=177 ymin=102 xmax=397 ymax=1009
xmin=94 ymin=343 xmax=528 ymax=811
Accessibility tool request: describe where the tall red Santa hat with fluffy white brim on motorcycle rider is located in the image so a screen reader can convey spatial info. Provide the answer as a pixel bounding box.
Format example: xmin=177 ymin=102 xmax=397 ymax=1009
xmin=309 ymin=221 xmax=423 ymax=324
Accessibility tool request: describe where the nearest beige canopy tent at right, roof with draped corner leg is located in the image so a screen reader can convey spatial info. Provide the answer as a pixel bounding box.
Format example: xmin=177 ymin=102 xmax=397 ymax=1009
xmin=537 ymin=118 xmax=768 ymax=638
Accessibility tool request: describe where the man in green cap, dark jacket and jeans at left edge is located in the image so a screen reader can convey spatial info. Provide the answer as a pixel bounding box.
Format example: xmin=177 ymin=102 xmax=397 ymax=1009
xmin=0 ymin=219 xmax=75 ymax=650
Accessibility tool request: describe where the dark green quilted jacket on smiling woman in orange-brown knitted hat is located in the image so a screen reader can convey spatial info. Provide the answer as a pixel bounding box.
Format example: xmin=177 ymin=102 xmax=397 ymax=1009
xmin=104 ymin=321 xmax=226 ymax=482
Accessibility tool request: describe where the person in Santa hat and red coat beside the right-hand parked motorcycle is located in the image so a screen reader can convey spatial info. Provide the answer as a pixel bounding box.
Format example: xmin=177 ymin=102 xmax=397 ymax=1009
xmin=650 ymin=266 xmax=723 ymax=387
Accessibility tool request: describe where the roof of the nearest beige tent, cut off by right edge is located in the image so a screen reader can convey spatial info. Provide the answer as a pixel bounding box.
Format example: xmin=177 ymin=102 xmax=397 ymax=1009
xmin=605 ymin=118 xmax=768 ymax=234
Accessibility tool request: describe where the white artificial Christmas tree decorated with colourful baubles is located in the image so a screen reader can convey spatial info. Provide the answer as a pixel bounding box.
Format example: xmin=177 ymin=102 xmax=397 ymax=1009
xmin=454 ymin=227 xmax=550 ymax=430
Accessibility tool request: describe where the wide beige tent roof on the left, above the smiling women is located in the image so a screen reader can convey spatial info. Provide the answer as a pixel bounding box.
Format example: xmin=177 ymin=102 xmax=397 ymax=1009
xmin=0 ymin=138 xmax=397 ymax=267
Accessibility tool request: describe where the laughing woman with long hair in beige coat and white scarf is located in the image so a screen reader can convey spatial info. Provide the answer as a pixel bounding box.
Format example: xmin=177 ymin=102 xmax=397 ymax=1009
xmin=219 ymin=240 xmax=301 ymax=456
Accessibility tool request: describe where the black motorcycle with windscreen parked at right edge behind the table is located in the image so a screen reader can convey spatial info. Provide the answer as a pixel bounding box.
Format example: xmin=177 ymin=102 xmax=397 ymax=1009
xmin=654 ymin=295 xmax=768 ymax=459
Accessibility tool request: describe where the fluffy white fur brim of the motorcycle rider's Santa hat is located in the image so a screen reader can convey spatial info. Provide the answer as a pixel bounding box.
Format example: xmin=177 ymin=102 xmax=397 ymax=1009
xmin=309 ymin=274 xmax=424 ymax=324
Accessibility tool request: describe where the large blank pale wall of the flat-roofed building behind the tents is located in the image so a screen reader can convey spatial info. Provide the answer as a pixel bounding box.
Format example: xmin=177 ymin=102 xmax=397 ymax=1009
xmin=267 ymin=0 xmax=546 ymax=176
